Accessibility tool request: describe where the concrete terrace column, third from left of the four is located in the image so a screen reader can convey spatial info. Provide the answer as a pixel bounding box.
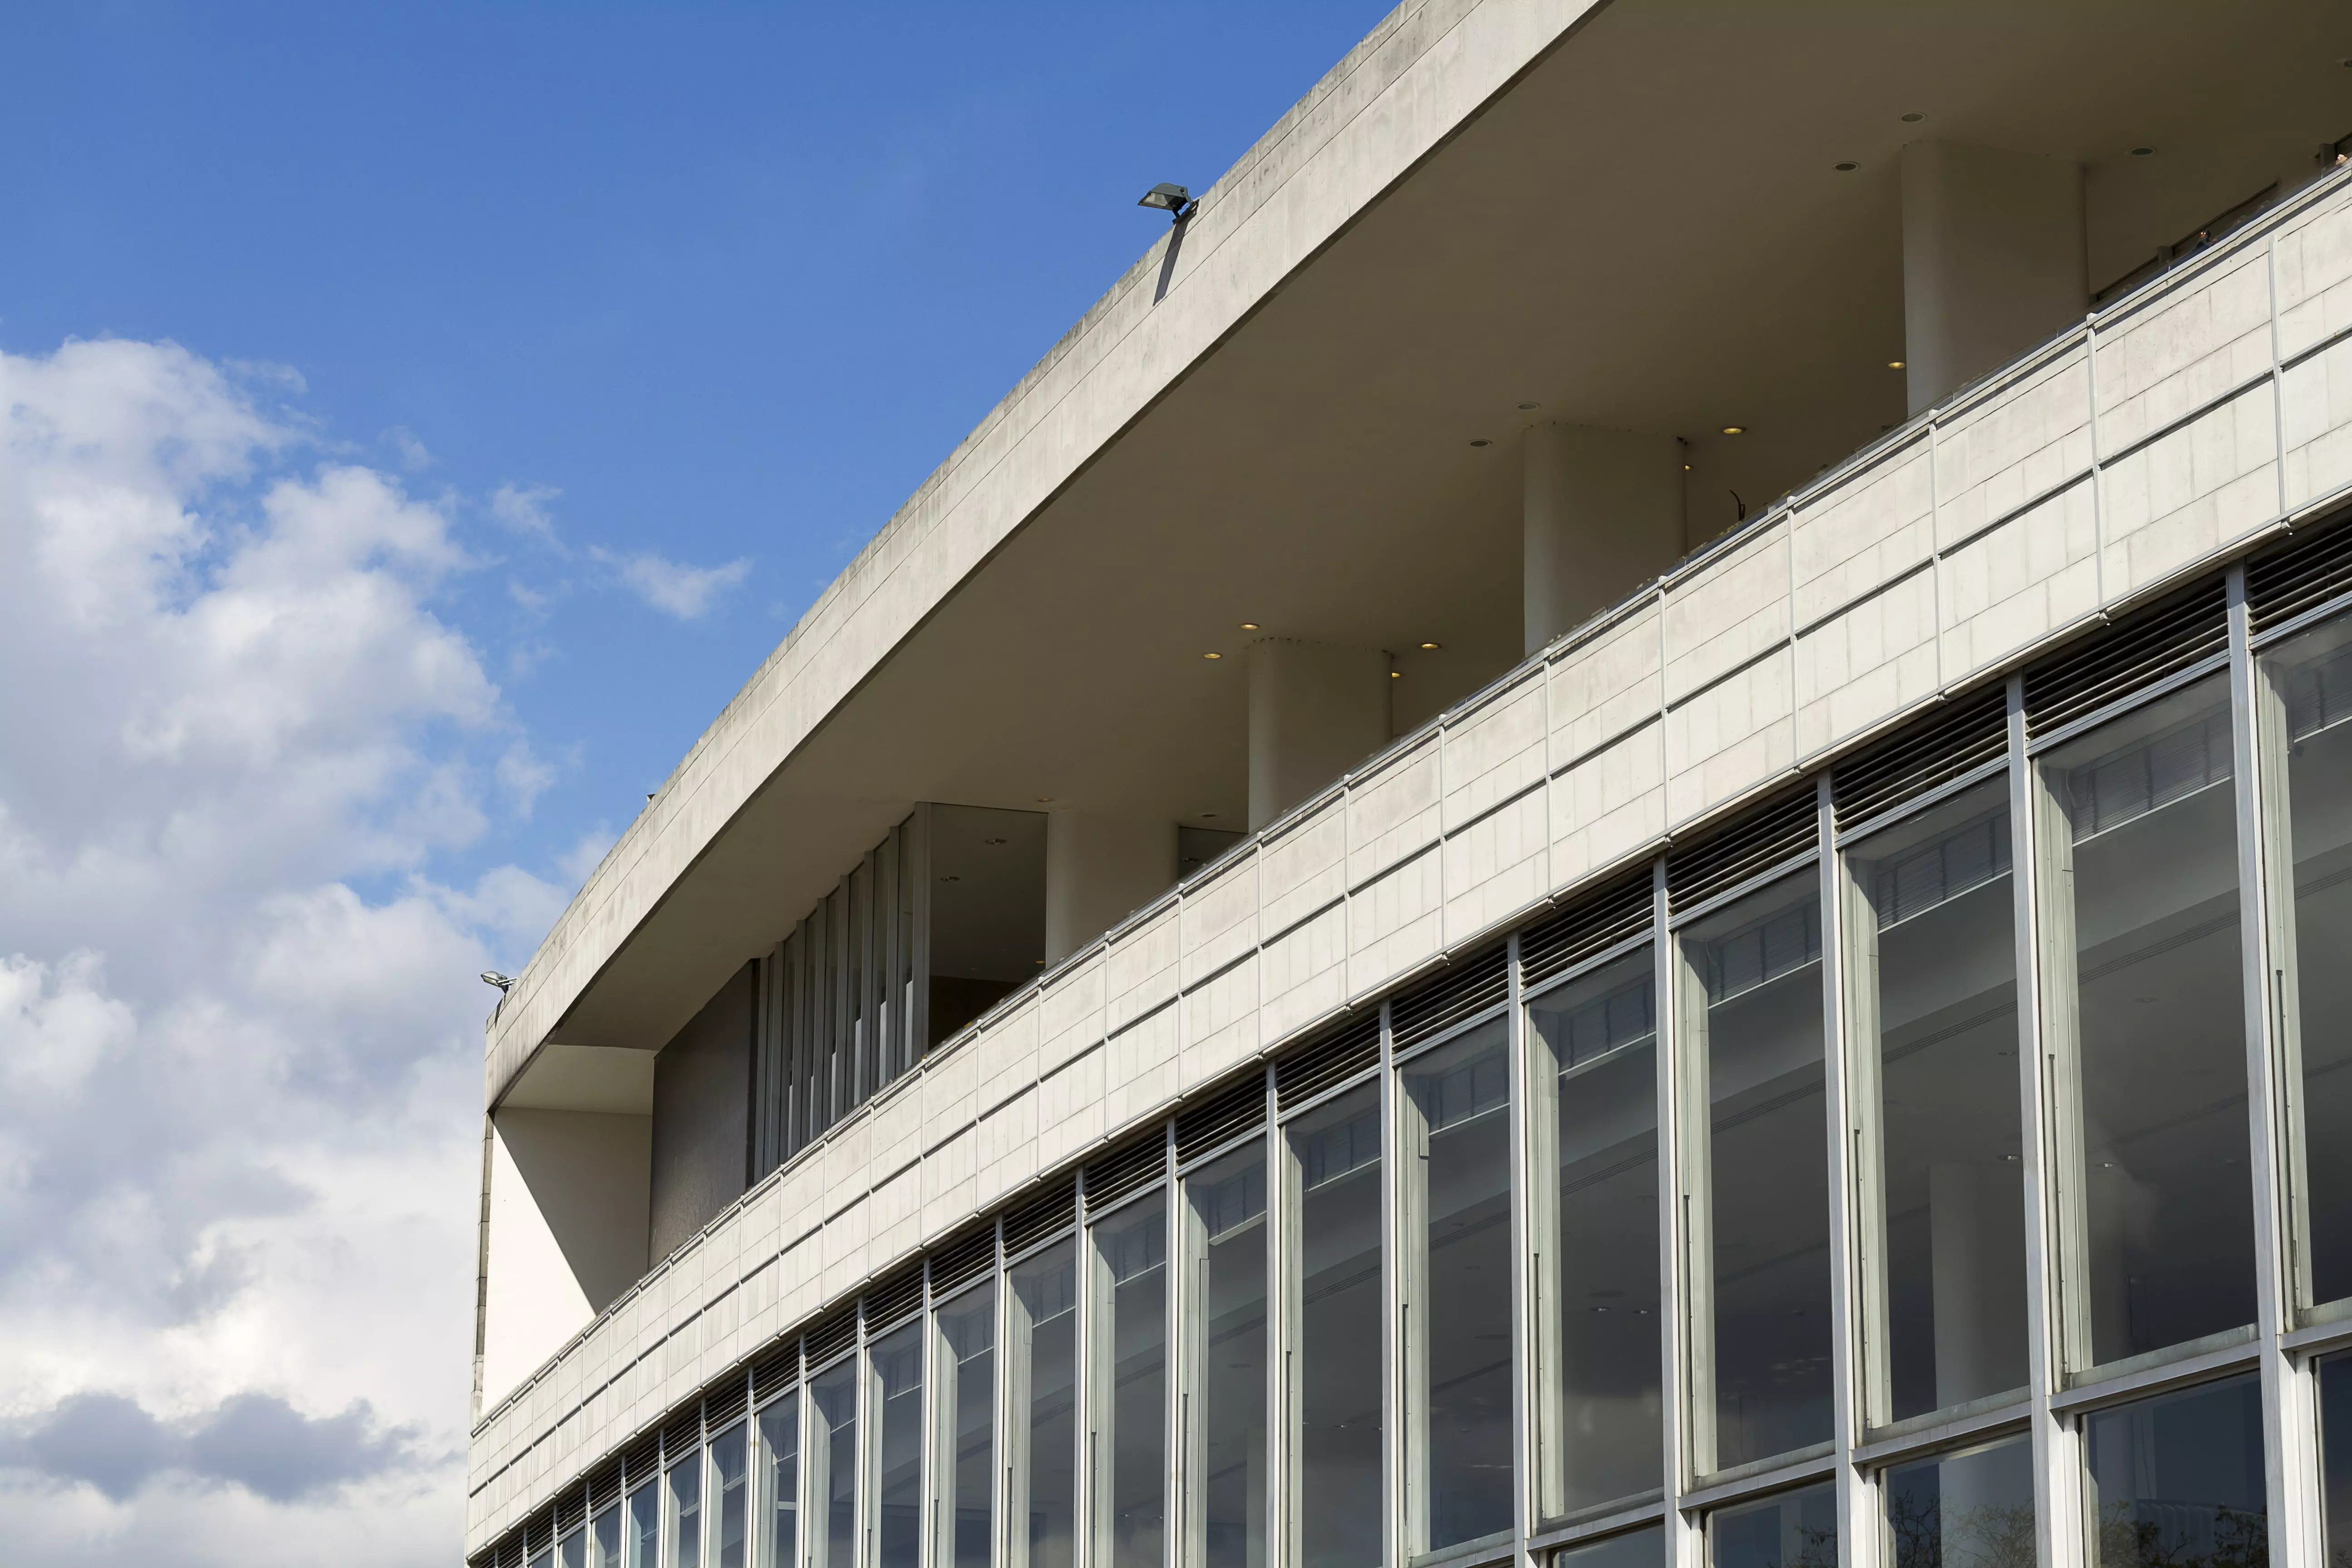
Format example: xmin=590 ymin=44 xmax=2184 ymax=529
xmin=1519 ymin=423 xmax=1682 ymax=653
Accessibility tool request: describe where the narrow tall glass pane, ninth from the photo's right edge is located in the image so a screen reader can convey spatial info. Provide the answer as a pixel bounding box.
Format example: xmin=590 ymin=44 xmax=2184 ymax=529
xmin=1094 ymin=1192 xmax=1169 ymax=1568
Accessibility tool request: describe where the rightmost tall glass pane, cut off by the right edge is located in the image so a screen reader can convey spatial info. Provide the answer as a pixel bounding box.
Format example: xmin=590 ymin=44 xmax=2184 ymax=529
xmin=2265 ymin=618 xmax=2352 ymax=1305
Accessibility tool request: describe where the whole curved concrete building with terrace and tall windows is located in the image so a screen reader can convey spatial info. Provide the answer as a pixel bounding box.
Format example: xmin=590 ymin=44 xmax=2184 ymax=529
xmin=468 ymin=0 xmax=2352 ymax=1568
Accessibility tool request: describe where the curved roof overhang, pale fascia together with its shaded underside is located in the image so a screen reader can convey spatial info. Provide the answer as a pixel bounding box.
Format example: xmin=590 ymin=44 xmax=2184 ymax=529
xmin=487 ymin=0 xmax=2352 ymax=1102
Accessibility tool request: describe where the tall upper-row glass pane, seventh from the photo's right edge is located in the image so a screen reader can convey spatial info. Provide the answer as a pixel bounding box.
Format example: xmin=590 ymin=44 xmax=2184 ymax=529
xmin=1287 ymin=1084 xmax=1383 ymax=1568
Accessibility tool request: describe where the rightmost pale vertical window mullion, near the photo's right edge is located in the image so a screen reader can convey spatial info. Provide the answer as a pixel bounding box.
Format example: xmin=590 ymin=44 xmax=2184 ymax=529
xmin=2230 ymin=564 xmax=2326 ymax=1568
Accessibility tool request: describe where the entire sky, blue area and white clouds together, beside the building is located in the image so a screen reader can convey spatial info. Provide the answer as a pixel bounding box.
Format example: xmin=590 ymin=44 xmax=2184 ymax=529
xmin=0 ymin=2 xmax=1378 ymax=1568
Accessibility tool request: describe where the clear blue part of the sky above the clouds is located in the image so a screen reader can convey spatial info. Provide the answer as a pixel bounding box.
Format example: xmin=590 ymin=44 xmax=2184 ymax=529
xmin=0 ymin=0 xmax=1383 ymax=926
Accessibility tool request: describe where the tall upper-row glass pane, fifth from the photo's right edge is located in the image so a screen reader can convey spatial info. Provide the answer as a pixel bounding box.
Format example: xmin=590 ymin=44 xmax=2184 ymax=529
xmin=1526 ymin=947 xmax=1665 ymax=1519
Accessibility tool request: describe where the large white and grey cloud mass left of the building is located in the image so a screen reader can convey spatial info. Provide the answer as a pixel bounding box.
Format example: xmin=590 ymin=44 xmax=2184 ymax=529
xmin=0 ymin=341 xmax=572 ymax=1566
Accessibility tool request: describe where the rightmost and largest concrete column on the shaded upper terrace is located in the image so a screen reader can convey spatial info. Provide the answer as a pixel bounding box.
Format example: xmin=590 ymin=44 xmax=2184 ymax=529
xmin=1903 ymin=141 xmax=2091 ymax=414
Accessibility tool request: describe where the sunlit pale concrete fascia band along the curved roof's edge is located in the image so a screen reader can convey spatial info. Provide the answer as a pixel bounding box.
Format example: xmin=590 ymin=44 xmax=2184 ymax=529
xmin=485 ymin=0 xmax=1604 ymax=1105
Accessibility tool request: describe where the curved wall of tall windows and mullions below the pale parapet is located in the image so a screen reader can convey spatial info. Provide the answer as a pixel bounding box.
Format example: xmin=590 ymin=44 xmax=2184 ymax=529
xmin=475 ymin=512 xmax=2352 ymax=1568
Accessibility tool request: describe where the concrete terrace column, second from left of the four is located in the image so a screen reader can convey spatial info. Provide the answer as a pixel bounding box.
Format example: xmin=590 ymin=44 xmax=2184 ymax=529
xmin=1249 ymin=637 xmax=1390 ymax=830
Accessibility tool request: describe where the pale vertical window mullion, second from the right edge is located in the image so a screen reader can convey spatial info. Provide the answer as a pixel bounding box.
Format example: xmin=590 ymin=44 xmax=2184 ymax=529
xmin=2009 ymin=675 xmax=2086 ymax=1566
